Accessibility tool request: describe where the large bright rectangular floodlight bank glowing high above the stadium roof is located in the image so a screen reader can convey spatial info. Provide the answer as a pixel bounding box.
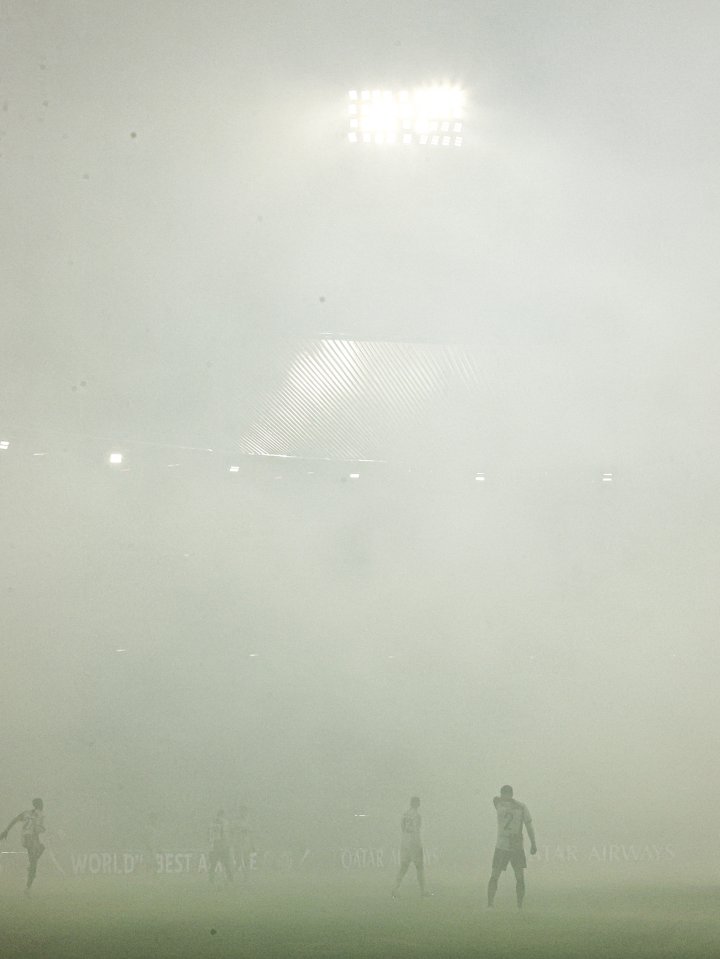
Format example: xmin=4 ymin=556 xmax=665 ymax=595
xmin=348 ymin=84 xmax=465 ymax=147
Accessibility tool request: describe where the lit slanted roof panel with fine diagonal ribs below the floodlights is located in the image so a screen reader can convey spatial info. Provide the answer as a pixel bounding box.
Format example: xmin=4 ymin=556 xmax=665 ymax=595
xmin=236 ymin=336 xmax=480 ymax=460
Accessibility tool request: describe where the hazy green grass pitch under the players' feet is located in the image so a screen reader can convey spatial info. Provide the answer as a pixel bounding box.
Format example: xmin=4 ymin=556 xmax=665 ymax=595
xmin=0 ymin=877 xmax=720 ymax=959
